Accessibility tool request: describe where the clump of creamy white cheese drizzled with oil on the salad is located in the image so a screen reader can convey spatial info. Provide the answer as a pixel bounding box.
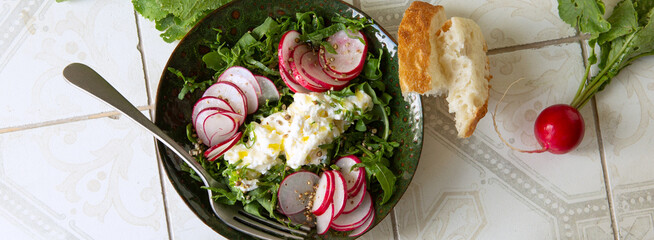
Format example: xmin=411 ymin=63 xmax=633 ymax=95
xmin=225 ymin=88 xmax=372 ymax=190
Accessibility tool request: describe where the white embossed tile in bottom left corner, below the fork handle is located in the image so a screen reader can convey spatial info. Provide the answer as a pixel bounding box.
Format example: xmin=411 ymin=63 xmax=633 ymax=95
xmin=0 ymin=113 xmax=168 ymax=239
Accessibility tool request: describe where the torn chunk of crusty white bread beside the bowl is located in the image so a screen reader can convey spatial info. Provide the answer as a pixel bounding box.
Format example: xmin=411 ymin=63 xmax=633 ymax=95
xmin=398 ymin=2 xmax=491 ymax=138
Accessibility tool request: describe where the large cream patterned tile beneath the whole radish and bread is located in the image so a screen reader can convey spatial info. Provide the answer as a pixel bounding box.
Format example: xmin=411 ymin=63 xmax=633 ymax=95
xmin=396 ymin=44 xmax=612 ymax=239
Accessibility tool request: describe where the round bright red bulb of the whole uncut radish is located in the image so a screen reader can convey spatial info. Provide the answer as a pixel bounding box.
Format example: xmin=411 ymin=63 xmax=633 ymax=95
xmin=534 ymin=104 xmax=585 ymax=154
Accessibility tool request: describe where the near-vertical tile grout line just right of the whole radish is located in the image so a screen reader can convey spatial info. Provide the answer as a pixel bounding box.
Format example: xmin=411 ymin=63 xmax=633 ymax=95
xmin=577 ymin=35 xmax=620 ymax=240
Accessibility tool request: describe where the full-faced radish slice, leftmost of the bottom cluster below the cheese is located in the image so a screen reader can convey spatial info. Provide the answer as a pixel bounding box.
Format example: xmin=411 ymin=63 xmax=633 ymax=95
xmin=277 ymin=171 xmax=320 ymax=216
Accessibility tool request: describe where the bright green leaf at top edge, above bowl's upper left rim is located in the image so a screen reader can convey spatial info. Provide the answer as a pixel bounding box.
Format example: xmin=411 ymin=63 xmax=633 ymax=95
xmin=132 ymin=0 xmax=230 ymax=42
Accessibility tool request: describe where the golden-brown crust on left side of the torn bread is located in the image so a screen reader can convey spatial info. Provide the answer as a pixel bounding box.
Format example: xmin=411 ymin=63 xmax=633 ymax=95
xmin=397 ymin=1 xmax=445 ymax=94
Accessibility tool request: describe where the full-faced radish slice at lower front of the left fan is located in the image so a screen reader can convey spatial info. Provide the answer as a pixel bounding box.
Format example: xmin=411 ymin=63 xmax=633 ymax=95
xmin=203 ymin=112 xmax=238 ymax=146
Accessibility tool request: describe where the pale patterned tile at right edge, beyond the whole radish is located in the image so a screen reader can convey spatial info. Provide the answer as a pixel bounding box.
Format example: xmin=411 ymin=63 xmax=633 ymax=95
xmin=597 ymin=52 xmax=654 ymax=239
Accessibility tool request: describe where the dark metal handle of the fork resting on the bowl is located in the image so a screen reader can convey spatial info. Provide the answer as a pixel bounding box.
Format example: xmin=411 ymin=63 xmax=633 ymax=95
xmin=64 ymin=63 xmax=217 ymax=186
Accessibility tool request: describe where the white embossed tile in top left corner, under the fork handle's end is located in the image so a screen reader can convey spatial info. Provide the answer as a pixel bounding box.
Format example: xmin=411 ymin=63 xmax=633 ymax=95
xmin=0 ymin=0 xmax=146 ymax=128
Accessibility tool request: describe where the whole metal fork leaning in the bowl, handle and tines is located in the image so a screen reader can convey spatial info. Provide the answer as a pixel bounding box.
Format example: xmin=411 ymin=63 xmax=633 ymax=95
xmin=63 ymin=63 xmax=310 ymax=239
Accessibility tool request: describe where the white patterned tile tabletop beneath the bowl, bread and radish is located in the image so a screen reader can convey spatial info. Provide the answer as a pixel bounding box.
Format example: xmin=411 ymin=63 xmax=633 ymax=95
xmin=0 ymin=0 xmax=654 ymax=239
